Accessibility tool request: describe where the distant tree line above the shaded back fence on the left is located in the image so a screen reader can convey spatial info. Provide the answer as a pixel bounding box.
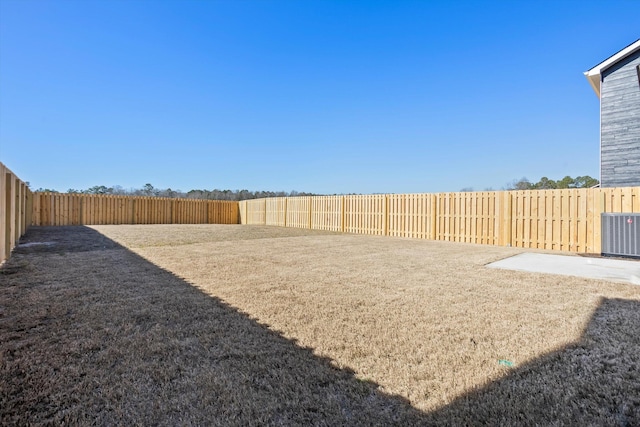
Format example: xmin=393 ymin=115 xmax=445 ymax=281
xmin=35 ymin=184 xmax=316 ymax=201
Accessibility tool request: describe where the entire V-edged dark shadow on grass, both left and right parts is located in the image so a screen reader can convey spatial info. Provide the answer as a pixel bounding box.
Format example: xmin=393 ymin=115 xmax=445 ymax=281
xmin=0 ymin=227 xmax=640 ymax=425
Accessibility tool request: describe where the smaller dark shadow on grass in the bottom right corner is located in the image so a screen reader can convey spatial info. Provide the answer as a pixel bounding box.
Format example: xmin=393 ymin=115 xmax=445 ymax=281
xmin=426 ymin=298 xmax=640 ymax=426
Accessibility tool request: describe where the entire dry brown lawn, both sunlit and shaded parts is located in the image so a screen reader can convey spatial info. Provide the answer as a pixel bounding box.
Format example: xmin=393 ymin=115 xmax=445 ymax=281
xmin=0 ymin=225 xmax=640 ymax=425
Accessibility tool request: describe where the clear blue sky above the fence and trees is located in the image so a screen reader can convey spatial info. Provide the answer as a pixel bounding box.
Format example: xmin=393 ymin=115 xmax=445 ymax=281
xmin=0 ymin=0 xmax=640 ymax=194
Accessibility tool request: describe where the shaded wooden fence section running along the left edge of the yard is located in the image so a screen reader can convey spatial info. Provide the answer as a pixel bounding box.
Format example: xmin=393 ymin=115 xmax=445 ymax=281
xmin=0 ymin=163 xmax=33 ymax=263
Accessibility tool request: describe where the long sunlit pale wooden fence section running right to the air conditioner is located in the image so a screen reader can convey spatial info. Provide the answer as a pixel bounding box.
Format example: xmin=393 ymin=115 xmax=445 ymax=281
xmin=240 ymin=187 xmax=640 ymax=253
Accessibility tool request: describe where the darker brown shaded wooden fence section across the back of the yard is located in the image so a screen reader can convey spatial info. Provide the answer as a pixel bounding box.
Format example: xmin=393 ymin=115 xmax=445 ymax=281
xmin=32 ymin=193 xmax=239 ymax=225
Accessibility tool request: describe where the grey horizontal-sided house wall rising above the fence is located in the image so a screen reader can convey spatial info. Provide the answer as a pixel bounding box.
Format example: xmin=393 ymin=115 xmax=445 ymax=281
xmin=600 ymin=51 xmax=640 ymax=187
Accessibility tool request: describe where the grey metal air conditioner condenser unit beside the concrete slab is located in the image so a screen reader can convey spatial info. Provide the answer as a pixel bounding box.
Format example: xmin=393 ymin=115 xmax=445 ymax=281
xmin=602 ymin=213 xmax=640 ymax=258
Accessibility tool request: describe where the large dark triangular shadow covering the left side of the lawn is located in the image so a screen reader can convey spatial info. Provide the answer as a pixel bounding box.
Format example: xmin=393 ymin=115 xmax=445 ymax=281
xmin=0 ymin=226 xmax=430 ymax=425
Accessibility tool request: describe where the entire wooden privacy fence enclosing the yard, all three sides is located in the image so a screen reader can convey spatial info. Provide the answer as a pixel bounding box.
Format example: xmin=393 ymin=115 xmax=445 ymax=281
xmin=0 ymin=163 xmax=640 ymax=262
